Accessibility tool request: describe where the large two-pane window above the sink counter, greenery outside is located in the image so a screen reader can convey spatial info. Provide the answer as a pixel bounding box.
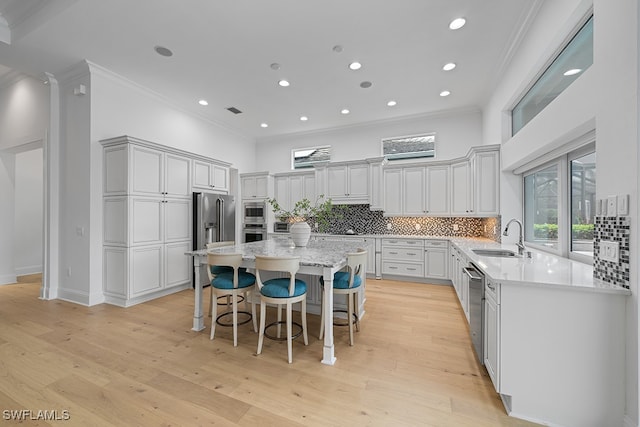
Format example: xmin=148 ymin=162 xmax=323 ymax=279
xmin=523 ymin=143 xmax=596 ymax=262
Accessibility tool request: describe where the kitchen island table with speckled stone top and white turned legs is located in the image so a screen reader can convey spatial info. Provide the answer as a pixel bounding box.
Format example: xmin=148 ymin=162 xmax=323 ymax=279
xmin=186 ymin=237 xmax=365 ymax=365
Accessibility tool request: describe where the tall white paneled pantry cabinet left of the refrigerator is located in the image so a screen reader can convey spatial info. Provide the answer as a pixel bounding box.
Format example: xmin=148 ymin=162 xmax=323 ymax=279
xmin=101 ymin=136 xmax=232 ymax=307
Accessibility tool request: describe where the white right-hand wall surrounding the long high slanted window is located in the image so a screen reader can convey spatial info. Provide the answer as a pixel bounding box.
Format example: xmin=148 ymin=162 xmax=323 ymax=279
xmin=483 ymin=0 xmax=640 ymax=426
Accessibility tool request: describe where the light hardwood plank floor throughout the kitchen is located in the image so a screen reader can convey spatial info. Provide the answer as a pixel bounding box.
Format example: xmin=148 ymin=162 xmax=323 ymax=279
xmin=0 ymin=276 xmax=533 ymax=427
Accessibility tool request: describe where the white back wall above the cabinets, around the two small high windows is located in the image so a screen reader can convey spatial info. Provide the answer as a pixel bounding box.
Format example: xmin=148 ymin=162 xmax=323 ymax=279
xmin=254 ymin=110 xmax=482 ymax=173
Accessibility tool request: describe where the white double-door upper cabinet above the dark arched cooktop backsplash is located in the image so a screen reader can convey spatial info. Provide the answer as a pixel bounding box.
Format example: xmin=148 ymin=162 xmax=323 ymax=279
xmin=325 ymin=163 xmax=369 ymax=204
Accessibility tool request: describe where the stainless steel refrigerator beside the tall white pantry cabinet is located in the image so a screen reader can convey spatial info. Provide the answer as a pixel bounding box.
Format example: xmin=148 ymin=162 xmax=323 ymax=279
xmin=193 ymin=193 xmax=236 ymax=285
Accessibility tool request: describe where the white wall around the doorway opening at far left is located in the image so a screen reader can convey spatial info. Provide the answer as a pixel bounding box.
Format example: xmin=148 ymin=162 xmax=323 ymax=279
xmin=0 ymin=76 xmax=49 ymax=284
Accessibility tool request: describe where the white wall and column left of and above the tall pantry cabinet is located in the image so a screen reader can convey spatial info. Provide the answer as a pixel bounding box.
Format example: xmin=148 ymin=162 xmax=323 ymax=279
xmin=53 ymin=62 xmax=255 ymax=305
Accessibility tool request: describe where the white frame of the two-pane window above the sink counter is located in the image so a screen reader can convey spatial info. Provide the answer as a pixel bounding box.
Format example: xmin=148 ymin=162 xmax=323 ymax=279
xmin=521 ymin=143 xmax=597 ymax=264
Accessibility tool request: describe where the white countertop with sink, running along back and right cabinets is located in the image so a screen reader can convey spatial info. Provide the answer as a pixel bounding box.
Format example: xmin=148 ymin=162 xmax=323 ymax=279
xmin=272 ymin=233 xmax=631 ymax=295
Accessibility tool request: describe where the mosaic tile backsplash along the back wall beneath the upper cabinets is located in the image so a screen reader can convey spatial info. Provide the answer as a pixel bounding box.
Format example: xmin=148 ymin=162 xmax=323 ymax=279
xmin=310 ymin=205 xmax=500 ymax=242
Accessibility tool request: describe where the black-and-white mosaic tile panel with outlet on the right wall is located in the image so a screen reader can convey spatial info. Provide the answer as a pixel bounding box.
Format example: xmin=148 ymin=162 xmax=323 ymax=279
xmin=593 ymin=216 xmax=631 ymax=289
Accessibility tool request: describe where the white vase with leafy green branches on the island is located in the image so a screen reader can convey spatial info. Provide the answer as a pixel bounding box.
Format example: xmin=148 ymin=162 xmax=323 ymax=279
xmin=267 ymin=194 xmax=342 ymax=246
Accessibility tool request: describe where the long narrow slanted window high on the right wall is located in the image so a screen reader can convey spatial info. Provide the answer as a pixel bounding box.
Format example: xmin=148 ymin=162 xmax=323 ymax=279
xmin=511 ymin=16 xmax=593 ymax=135
